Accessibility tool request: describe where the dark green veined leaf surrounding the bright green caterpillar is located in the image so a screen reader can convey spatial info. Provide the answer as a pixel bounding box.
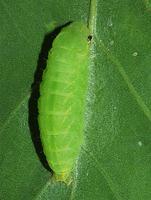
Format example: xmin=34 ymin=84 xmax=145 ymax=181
xmin=0 ymin=0 xmax=151 ymax=200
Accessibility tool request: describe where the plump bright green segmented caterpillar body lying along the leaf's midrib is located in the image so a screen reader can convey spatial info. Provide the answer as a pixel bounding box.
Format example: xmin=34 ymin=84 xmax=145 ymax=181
xmin=38 ymin=22 xmax=89 ymax=181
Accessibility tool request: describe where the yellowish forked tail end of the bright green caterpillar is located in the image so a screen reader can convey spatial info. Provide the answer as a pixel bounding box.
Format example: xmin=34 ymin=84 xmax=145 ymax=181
xmin=53 ymin=172 xmax=72 ymax=185
